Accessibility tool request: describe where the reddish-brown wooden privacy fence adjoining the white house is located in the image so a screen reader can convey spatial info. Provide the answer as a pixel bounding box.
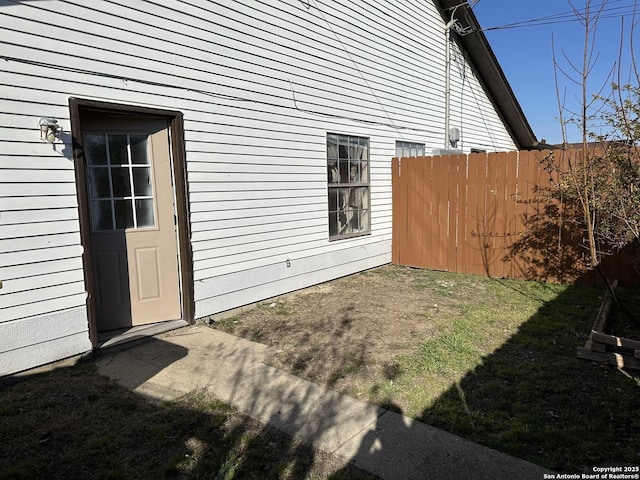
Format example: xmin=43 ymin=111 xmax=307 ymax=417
xmin=392 ymin=151 xmax=638 ymax=284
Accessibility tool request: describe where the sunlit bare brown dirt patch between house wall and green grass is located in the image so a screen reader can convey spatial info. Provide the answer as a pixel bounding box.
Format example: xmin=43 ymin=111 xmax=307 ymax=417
xmin=209 ymin=266 xmax=482 ymax=402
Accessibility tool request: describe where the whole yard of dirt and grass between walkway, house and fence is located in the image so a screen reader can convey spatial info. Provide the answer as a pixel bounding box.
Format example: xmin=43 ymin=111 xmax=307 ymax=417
xmin=206 ymin=266 xmax=640 ymax=473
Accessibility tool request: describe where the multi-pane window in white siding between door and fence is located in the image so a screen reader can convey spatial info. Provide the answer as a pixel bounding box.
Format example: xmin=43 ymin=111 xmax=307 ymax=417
xmin=327 ymin=133 xmax=371 ymax=240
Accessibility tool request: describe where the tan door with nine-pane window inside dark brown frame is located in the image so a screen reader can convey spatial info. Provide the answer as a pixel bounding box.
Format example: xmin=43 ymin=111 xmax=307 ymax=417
xmin=81 ymin=114 xmax=181 ymax=331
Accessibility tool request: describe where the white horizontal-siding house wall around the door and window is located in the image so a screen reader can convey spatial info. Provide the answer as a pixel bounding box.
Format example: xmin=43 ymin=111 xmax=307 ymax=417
xmin=0 ymin=0 xmax=515 ymax=375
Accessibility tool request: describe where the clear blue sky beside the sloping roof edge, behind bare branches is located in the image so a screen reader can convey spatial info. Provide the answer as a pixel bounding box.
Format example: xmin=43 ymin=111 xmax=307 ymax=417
xmin=470 ymin=0 xmax=640 ymax=143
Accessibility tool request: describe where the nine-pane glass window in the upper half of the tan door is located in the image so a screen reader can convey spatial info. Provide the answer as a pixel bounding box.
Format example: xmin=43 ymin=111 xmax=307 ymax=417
xmin=84 ymin=133 xmax=155 ymax=232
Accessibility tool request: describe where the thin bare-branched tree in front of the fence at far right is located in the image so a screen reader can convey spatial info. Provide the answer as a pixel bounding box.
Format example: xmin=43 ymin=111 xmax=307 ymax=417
xmin=549 ymin=0 xmax=640 ymax=273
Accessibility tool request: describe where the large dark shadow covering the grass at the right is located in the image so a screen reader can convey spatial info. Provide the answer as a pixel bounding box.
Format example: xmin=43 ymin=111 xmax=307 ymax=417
xmin=336 ymin=280 xmax=640 ymax=478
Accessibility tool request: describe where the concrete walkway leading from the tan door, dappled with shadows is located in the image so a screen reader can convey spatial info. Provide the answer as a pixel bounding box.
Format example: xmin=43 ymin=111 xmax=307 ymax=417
xmin=97 ymin=326 xmax=552 ymax=480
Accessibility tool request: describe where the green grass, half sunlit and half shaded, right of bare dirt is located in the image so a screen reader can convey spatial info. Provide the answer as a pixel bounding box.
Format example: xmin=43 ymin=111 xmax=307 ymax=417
xmin=378 ymin=272 xmax=640 ymax=473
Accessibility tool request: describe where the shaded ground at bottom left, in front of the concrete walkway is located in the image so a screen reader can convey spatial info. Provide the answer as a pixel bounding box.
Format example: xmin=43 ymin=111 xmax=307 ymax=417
xmin=0 ymin=340 xmax=370 ymax=479
